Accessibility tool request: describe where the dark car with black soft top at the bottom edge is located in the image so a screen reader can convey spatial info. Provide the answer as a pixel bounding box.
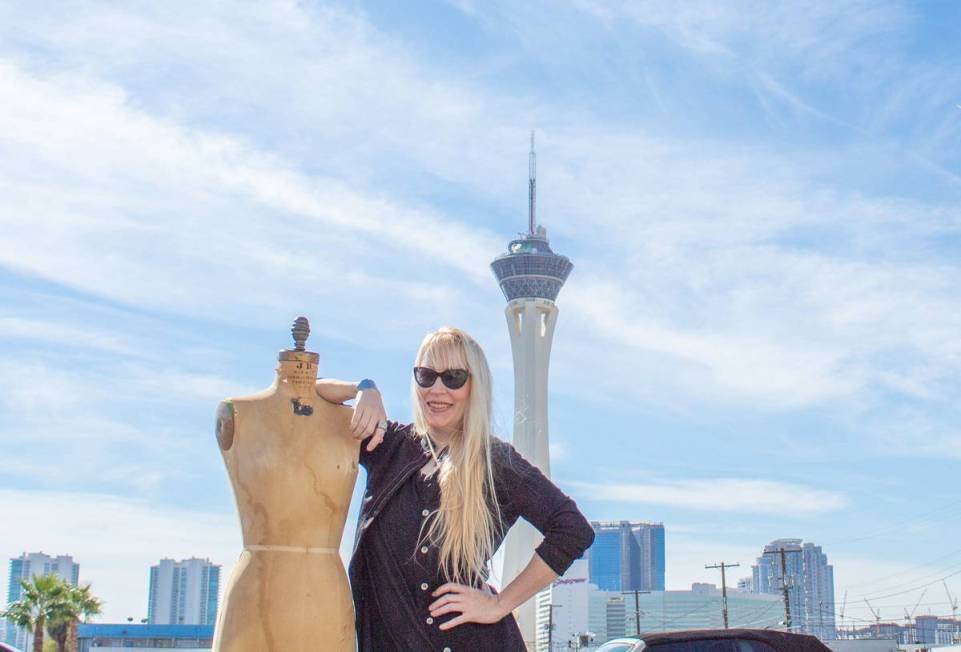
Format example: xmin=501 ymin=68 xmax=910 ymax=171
xmin=596 ymin=629 xmax=831 ymax=652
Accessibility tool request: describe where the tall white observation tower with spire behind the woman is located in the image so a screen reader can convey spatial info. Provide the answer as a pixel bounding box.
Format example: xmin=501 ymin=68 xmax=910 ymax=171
xmin=491 ymin=133 xmax=574 ymax=650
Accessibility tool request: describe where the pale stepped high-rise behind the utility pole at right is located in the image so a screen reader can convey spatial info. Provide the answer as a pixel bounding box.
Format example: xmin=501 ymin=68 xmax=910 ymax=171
xmin=751 ymin=539 xmax=836 ymax=640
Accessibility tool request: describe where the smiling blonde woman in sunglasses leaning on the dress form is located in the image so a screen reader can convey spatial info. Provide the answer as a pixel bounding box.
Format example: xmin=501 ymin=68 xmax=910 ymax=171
xmin=317 ymin=328 xmax=594 ymax=652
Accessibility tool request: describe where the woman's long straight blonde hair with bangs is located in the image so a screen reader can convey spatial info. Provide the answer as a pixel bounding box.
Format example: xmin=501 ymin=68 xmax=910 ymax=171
xmin=411 ymin=327 xmax=501 ymax=584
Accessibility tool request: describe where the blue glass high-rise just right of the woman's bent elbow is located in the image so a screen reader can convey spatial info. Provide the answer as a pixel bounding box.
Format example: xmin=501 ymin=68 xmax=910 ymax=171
xmin=587 ymin=521 xmax=665 ymax=591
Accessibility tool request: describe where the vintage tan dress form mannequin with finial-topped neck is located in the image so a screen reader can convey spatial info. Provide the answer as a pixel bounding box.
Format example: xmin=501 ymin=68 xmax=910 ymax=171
xmin=213 ymin=317 xmax=360 ymax=652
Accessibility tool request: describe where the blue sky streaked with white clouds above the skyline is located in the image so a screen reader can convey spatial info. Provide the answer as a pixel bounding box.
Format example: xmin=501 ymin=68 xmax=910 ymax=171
xmin=0 ymin=0 xmax=961 ymax=623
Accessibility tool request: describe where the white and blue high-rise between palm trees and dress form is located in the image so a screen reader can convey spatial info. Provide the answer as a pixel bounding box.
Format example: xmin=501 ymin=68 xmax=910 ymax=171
xmin=147 ymin=558 xmax=220 ymax=625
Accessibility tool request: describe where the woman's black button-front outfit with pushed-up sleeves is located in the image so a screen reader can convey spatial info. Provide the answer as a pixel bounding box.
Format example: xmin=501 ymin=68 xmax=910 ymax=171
xmin=350 ymin=422 xmax=594 ymax=652
